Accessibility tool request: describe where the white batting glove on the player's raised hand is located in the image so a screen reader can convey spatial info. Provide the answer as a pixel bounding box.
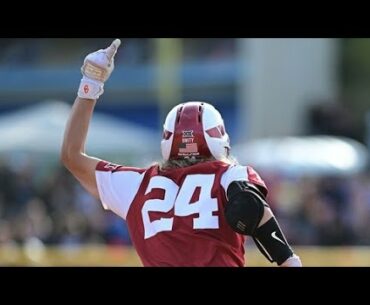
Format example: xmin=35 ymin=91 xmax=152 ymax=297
xmin=78 ymin=39 xmax=121 ymax=100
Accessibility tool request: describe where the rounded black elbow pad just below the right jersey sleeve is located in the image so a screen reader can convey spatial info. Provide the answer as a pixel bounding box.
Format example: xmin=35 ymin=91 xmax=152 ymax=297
xmin=224 ymin=181 xmax=265 ymax=235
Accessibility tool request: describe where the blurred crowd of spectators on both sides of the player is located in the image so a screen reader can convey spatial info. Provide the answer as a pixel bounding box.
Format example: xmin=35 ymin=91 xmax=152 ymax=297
xmin=0 ymin=156 xmax=370 ymax=246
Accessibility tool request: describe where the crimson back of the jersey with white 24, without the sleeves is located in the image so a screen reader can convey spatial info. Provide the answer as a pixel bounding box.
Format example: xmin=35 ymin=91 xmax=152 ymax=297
xmin=127 ymin=161 xmax=244 ymax=266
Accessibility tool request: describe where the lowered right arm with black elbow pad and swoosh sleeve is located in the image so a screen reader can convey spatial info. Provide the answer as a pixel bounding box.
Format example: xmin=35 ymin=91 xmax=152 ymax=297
xmin=225 ymin=181 xmax=302 ymax=267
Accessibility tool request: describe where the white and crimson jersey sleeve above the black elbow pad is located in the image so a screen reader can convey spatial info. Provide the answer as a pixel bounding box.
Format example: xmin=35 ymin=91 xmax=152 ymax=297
xmin=221 ymin=164 xmax=268 ymax=196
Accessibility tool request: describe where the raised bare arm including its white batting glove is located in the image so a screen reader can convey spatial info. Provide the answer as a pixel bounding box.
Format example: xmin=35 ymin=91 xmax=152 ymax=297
xmin=60 ymin=39 xmax=121 ymax=198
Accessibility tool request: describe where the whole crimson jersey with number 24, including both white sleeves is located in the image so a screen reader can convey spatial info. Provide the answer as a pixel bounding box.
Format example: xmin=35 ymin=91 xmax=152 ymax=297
xmin=96 ymin=161 xmax=267 ymax=266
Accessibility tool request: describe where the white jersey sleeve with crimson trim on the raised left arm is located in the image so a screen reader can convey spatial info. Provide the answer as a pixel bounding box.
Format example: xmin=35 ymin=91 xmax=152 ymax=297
xmin=95 ymin=161 xmax=145 ymax=219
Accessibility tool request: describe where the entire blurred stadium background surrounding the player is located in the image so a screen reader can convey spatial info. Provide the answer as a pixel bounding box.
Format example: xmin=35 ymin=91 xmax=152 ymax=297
xmin=0 ymin=38 xmax=370 ymax=266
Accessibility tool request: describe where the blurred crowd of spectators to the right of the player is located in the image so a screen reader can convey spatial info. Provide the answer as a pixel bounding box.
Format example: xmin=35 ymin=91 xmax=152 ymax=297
xmin=263 ymin=173 xmax=370 ymax=246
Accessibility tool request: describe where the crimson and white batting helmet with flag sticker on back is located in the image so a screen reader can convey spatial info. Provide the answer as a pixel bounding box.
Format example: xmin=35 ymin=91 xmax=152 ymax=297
xmin=161 ymin=102 xmax=230 ymax=161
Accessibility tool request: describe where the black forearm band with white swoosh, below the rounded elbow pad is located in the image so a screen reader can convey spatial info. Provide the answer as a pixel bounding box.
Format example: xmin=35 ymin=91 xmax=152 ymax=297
xmin=253 ymin=217 xmax=293 ymax=265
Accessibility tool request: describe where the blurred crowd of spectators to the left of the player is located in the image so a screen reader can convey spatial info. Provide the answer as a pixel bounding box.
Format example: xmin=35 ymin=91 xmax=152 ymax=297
xmin=0 ymin=162 xmax=130 ymax=246
